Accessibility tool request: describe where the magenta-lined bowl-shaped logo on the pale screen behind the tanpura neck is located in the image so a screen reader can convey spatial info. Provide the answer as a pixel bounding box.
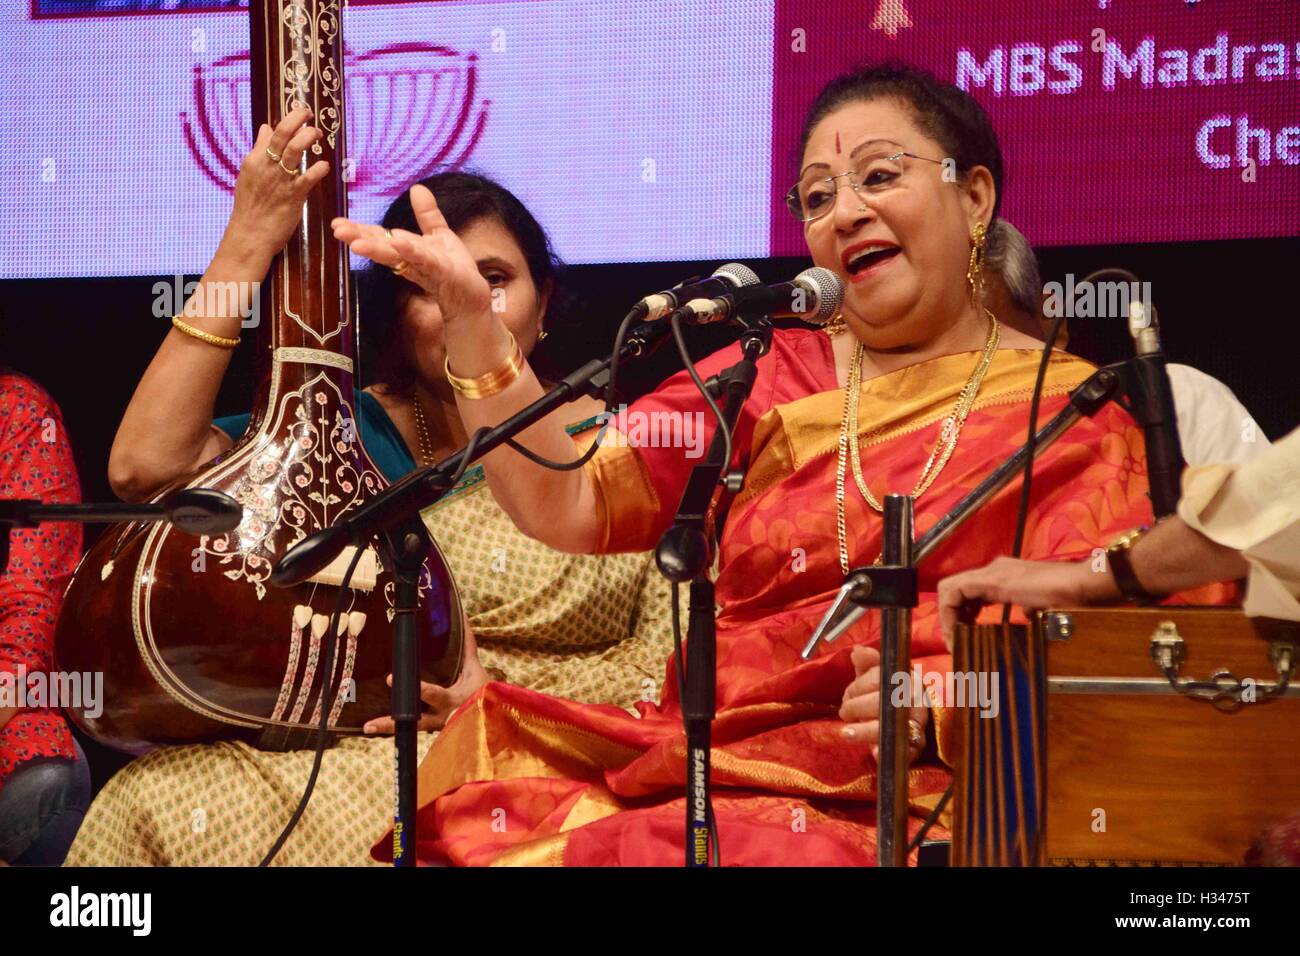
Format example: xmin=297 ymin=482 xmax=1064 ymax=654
xmin=181 ymin=43 xmax=491 ymax=196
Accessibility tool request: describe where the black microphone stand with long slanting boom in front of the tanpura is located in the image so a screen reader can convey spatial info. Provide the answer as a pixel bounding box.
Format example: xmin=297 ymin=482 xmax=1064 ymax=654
xmin=270 ymin=323 xmax=670 ymax=866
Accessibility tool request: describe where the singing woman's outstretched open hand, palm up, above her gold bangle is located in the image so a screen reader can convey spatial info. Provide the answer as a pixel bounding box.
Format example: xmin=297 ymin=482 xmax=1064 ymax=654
xmin=332 ymin=185 xmax=491 ymax=323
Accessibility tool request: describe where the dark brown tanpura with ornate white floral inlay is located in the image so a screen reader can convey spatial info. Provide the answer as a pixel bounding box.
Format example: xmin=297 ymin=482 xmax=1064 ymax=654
xmin=55 ymin=0 xmax=463 ymax=753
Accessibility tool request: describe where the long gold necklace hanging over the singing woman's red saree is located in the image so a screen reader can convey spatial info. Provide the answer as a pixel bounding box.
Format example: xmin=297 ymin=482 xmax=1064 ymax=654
xmin=835 ymin=308 xmax=1001 ymax=574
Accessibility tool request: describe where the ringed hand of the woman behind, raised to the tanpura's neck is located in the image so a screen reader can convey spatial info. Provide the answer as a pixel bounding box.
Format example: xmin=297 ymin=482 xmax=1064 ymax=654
xmin=222 ymin=107 xmax=329 ymax=259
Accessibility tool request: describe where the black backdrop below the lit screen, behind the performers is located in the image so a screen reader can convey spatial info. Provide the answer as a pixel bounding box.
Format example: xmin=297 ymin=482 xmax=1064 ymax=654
xmin=0 ymin=231 xmax=1300 ymax=790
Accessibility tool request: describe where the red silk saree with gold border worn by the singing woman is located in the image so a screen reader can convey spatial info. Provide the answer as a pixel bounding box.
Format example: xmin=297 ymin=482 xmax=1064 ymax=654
xmin=374 ymin=330 xmax=1223 ymax=866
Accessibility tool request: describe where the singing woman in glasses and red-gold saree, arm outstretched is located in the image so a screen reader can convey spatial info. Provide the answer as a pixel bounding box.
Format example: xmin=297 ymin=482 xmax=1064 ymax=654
xmin=335 ymin=68 xmax=1227 ymax=865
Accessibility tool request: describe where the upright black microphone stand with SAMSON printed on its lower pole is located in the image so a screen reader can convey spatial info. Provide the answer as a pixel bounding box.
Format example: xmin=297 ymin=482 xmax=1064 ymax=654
xmin=655 ymin=316 xmax=772 ymax=868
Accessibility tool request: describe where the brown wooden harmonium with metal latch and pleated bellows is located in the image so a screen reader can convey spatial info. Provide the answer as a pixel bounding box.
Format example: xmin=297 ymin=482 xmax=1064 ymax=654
xmin=952 ymin=607 xmax=1300 ymax=866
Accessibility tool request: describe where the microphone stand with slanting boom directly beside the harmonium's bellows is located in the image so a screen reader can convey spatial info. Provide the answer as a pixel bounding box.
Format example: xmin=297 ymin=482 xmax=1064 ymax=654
xmin=801 ymin=360 xmax=1134 ymax=866
